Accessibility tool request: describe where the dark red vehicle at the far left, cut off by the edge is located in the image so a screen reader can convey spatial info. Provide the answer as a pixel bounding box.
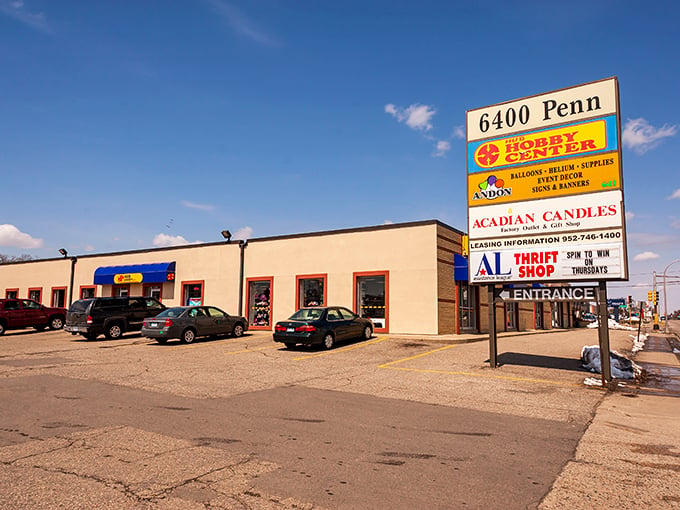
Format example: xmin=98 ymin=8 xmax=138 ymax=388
xmin=0 ymin=299 xmax=66 ymax=335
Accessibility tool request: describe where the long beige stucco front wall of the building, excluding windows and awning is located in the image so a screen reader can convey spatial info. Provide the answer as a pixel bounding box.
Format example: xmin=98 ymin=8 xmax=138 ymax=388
xmin=0 ymin=222 xmax=457 ymax=334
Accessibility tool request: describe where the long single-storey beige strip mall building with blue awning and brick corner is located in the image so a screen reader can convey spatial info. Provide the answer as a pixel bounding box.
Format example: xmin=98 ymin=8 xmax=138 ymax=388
xmin=0 ymin=220 xmax=573 ymax=335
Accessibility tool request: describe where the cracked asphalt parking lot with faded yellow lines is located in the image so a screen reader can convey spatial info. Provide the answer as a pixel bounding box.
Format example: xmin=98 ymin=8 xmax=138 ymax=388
xmin=0 ymin=324 xmax=668 ymax=508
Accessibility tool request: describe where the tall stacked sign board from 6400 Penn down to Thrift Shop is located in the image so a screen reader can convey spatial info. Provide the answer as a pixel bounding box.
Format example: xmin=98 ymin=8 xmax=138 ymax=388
xmin=467 ymin=78 xmax=628 ymax=284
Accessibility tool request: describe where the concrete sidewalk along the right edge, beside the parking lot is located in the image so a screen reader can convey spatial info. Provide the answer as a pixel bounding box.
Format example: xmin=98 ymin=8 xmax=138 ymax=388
xmin=539 ymin=331 xmax=680 ymax=510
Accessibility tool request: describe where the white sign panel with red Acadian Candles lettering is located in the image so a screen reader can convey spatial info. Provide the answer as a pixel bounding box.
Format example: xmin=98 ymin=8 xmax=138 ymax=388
xmin=468 ymin=190 xmax=624 ymax=239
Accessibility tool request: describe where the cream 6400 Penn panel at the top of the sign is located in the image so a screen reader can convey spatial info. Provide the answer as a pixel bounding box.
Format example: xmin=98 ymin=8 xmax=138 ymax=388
xmin=467 ymin=78 xmax=617 ymax=142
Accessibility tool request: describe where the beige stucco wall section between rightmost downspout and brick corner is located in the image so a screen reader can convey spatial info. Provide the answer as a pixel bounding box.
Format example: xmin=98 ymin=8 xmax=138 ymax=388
xmin=244 ymin=223 xmax=437 ymax=334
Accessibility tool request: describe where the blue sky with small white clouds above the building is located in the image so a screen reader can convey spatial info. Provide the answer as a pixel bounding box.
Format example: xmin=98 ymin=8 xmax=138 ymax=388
xmin=0 ymin=0 xmax=680 ymax=308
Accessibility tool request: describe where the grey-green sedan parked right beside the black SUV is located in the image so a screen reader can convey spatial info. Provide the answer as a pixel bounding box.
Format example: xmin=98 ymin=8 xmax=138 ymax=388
xmin=142 ymin=306 xmax=248 ymax=344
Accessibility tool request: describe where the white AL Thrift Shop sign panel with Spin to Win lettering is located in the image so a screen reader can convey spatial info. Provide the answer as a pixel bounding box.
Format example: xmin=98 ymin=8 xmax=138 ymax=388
xmin=469 ymin=243 xmax=625 ymax=284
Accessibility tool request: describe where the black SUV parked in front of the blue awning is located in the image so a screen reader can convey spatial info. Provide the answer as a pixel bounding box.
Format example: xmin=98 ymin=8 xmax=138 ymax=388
xmin=64 ymin=297 xmax=166 ymax=340
